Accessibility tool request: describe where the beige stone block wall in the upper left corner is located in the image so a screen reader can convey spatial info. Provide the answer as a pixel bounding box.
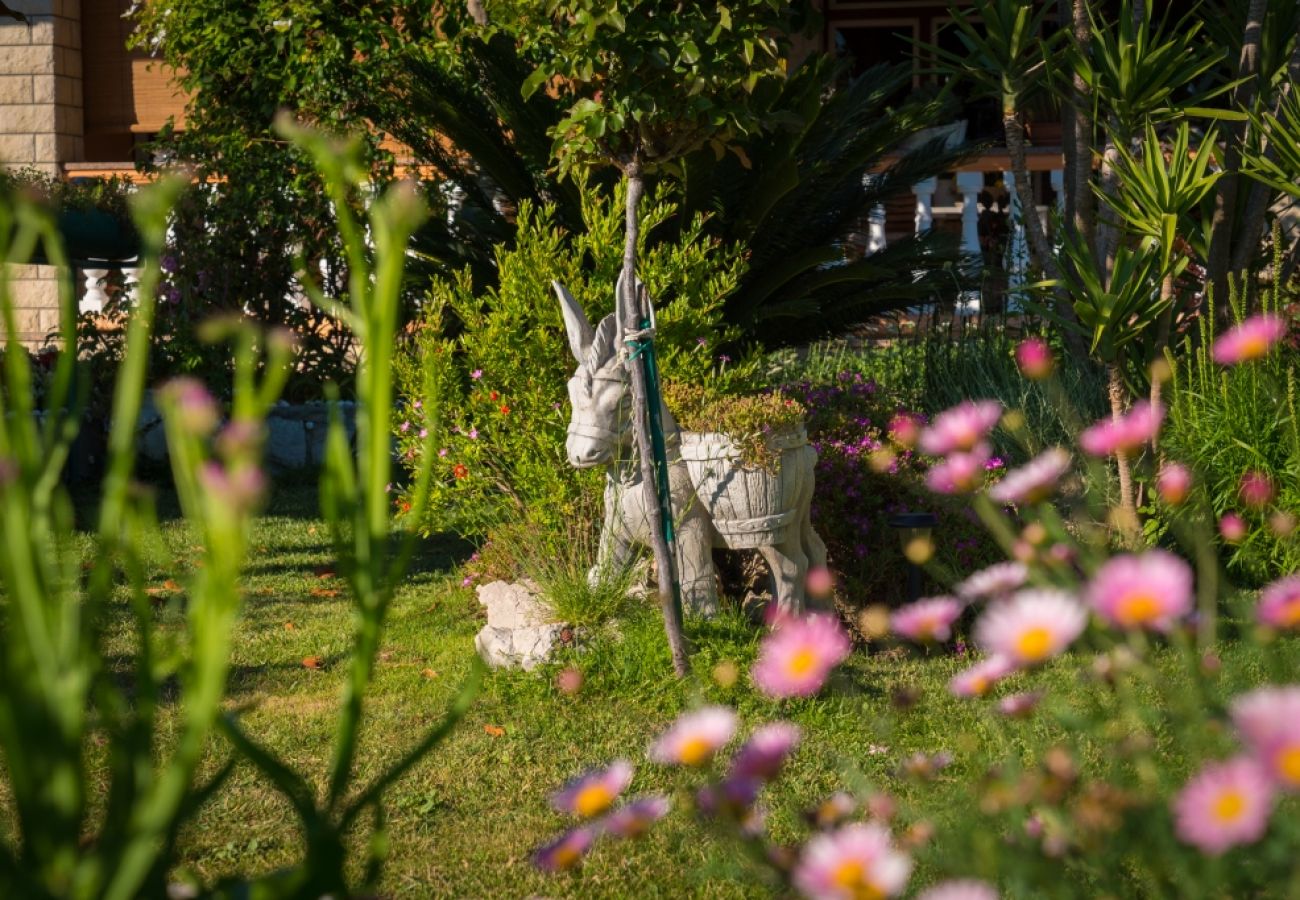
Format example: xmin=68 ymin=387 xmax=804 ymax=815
xmin=0 ymin=0 xmax=85 ymax=345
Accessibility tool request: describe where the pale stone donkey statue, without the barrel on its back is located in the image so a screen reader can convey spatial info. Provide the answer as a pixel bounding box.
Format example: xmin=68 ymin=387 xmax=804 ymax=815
xmin=553 ymin=282 xmax=826 ymax=615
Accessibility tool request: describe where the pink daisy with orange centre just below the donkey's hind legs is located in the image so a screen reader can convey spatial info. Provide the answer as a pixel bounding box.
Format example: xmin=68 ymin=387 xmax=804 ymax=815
xmin=750 ymin=614 xmax=853 ymax=698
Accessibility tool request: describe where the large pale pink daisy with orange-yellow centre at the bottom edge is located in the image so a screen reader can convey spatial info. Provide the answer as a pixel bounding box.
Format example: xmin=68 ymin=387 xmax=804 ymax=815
xmin=794 ymin=822 xmax=911 ymax=900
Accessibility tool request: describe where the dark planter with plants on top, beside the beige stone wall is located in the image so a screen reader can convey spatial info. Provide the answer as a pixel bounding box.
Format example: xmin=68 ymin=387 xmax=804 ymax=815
xmin=0 ymin=168 xmax=140 ymax=263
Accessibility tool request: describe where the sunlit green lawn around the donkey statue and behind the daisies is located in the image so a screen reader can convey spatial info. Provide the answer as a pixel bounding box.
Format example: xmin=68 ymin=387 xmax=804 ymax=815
xmin=89 ymin=488 xmax=1289 ymax=897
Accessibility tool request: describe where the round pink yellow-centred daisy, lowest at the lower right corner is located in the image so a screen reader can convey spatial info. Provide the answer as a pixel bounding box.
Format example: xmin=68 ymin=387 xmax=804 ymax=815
xmin=1173 ymin=756 xmax=1274 ymax=856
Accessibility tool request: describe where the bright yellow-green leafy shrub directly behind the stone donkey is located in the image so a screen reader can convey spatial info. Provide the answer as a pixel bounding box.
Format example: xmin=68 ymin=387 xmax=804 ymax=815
xmin=397 ymin=179 xmax=754 ymax=535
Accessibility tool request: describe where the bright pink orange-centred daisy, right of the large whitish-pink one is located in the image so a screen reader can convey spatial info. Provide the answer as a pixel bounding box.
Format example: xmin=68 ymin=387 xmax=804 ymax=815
xmin=1086 ymin=550 xmax=1193 ymax=631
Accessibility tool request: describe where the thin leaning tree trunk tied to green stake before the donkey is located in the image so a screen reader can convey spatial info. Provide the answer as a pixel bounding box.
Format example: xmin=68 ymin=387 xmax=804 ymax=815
xmin=618 ymin=159 xmax=690 ymax=678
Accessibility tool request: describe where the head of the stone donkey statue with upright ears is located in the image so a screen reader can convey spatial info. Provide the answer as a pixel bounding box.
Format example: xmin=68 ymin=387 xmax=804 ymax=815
xmin=551 ymin=280 xmax=631 ymax=468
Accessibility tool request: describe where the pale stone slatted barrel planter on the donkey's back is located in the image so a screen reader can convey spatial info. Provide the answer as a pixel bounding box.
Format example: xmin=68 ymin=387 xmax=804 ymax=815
xmin=681 ymin=425 xmax=815 ymax=550
